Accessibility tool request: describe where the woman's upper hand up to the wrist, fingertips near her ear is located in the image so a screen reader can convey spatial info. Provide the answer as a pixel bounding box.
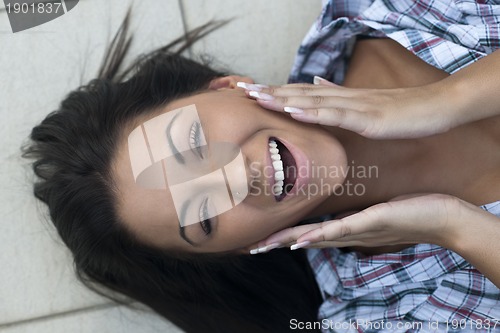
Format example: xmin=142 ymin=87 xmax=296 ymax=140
xmin=239 ymin=77 xmax=459 ymax=139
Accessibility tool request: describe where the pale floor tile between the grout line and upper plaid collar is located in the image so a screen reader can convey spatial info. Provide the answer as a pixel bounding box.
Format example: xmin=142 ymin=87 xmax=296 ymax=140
xmin=182 ymin=0 xmax=321 ymax=84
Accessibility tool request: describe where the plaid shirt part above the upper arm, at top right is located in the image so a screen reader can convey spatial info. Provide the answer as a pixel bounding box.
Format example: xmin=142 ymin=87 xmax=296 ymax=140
xmin=289 ymin=0 xmax=500 ymax=84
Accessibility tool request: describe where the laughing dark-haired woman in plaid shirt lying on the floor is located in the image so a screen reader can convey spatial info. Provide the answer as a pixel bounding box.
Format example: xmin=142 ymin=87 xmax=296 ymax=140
xmin=22 ymin=2 xmax=500 ymax=332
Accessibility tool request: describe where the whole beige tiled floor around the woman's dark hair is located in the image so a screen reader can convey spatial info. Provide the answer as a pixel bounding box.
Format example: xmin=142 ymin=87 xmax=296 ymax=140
xmin=0 ymin=0 xmax=320 ymax=333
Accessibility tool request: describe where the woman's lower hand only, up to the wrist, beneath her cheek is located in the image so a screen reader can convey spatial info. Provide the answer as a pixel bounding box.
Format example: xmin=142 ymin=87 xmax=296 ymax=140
xmin=251 ymin=194 xmax=462 ymax=254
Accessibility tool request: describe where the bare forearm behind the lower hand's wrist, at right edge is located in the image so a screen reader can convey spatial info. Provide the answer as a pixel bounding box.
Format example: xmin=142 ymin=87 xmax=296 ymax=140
xmin=443 ymin=202 xmax=500 ymax=288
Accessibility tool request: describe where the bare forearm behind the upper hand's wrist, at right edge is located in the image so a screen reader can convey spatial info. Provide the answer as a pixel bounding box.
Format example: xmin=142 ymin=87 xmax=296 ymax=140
xmin=441 ymin=50 xmax=500 ymax=126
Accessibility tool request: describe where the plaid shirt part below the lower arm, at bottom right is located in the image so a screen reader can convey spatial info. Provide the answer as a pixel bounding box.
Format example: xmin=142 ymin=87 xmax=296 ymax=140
xmin=307 ymin=201 xmax=500 ymax=332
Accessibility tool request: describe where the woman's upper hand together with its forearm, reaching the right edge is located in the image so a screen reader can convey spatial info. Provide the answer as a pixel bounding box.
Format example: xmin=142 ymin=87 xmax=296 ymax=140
xmin=238 ymin=50 xmax=500 ymax=139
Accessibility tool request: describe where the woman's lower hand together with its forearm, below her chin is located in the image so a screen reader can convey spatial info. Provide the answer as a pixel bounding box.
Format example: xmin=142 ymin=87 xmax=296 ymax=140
xmin=250 ymin=194 xmax=500 ymax=288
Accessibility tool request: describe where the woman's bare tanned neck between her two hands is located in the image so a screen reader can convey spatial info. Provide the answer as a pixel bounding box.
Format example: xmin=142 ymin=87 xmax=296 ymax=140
xmin=309 ymin=119 xmax=499 ymax=217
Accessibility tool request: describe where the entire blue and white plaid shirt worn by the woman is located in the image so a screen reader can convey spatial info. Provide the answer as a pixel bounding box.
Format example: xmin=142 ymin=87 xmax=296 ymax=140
xmin=289 ymin=0 xmax=500 ymax=332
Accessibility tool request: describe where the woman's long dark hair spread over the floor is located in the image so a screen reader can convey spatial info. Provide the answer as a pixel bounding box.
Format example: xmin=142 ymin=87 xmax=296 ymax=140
xmin=23 ymin=11 xmax=321 ymax=333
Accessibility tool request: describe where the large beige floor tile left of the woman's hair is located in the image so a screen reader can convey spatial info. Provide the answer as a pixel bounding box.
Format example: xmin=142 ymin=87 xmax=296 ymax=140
xmin=0 ymin=0 xmax=183 ymax=322
